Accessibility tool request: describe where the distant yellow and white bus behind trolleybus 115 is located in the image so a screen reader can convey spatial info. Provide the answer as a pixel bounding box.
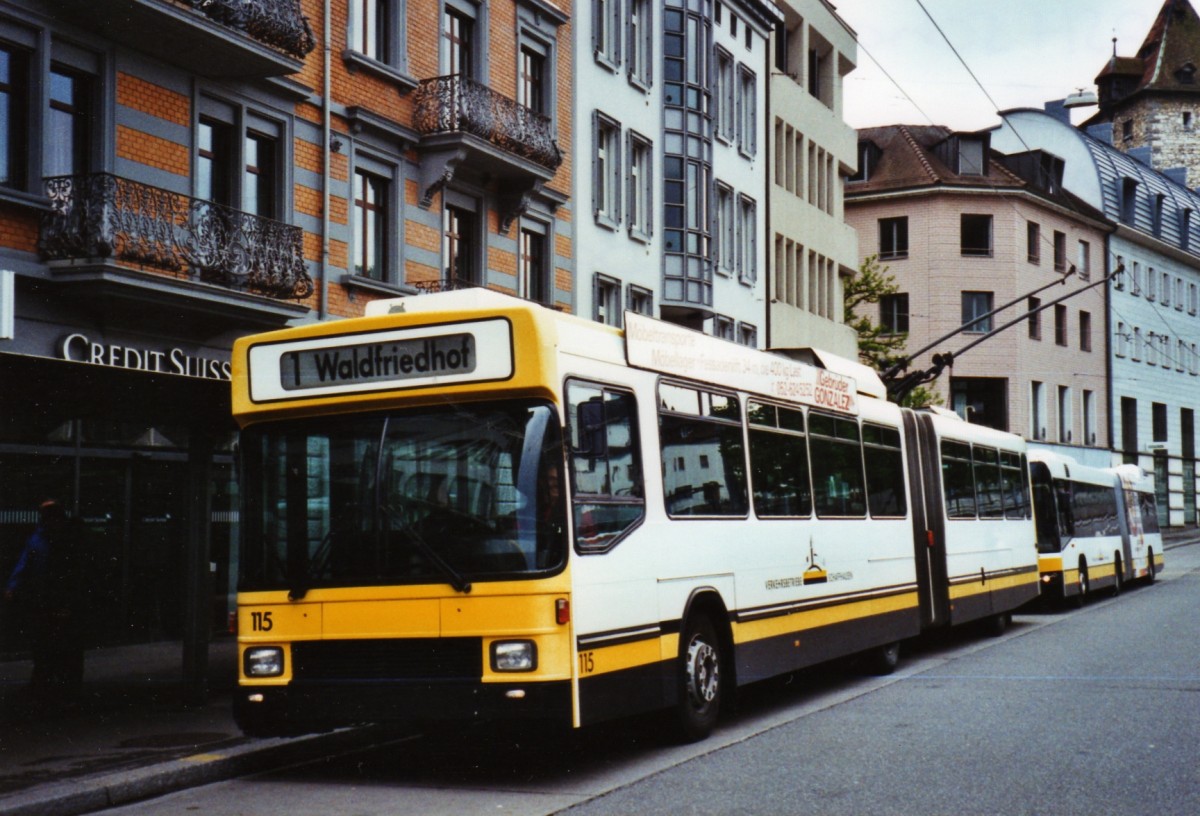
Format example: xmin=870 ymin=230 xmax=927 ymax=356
xmin=1030 ymin=450 xmax=1163 ymax=606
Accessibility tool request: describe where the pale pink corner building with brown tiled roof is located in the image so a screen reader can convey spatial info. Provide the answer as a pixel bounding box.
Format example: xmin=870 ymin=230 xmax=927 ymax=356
xmin=846 ymin=125 xmax=1111 ymax=450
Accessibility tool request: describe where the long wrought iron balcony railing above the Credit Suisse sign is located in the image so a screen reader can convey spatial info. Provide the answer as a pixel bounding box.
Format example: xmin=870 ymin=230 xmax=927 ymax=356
xmin=37 ymin=173 xmax=313 ymax=299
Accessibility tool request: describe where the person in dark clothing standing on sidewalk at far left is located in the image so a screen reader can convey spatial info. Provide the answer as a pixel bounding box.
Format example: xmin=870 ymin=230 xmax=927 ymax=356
xmin=4 ymin=499 xmax=86 ymax=703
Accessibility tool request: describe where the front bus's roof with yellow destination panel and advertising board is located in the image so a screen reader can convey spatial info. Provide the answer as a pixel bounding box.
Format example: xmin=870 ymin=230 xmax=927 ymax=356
xmin=233 ymin=288 xmax=886 ymax=422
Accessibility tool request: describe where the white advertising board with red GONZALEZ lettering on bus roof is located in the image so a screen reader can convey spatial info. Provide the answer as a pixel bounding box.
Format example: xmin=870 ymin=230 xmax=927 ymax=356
xmin=625 ymin=312 xmax=858 ymax=414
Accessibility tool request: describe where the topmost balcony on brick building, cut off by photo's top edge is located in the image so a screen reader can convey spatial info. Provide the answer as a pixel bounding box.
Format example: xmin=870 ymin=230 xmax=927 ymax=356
xmin=55 ymin=0 xmax=316 ymax=78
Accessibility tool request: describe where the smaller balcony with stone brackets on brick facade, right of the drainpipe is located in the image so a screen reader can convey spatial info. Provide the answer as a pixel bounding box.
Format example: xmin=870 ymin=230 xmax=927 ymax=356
xmin=413 ymin=76 xmax=563 ymax=230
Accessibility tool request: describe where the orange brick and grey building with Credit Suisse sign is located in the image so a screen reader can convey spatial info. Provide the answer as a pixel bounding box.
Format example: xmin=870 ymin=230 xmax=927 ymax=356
xmin=0 ymin=0 xmax=576 ymax=676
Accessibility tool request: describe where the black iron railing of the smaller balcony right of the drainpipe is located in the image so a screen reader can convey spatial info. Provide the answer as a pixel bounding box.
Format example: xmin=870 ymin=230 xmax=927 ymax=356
xmin=414 ymin=76 xmax=563 ymax=170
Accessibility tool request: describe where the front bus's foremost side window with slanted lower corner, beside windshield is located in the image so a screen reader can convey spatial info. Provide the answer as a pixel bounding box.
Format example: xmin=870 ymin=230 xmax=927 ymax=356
xmin=566 ymin=382 xmax=646 ymax=552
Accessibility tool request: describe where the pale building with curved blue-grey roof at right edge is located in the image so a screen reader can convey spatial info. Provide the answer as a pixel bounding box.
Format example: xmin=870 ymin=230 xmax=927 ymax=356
xmin=992 ymin=109 xmax=1200 ymax=526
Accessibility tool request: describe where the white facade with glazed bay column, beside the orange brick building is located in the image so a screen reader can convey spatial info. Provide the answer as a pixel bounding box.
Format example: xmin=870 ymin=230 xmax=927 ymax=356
xmin=572 ymin=0 xmax=779 ymax=347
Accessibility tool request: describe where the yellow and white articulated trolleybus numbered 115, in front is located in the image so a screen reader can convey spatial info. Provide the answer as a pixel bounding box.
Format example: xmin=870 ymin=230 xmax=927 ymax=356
xmin=233 ymin=289 xmax=1038 ymax=739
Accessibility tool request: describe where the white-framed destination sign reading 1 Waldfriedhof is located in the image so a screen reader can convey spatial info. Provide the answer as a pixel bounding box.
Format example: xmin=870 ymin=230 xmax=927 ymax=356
xmin=248 ymin=318 xmax=514 ymax=402
